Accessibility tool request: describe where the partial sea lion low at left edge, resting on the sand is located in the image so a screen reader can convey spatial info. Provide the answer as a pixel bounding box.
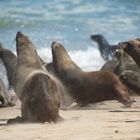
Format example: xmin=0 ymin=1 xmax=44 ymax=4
xmin=0 ymin=79 xmax=15 ymax=107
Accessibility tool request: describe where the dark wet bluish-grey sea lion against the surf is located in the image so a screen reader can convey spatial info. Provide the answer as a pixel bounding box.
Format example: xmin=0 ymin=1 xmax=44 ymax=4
xmin=90 ymin=34 xmax=118 ymax=61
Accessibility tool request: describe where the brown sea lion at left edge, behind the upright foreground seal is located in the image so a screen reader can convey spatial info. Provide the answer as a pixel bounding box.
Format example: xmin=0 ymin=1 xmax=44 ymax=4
xmin=0 ymin=44 xmax=17 ymax=87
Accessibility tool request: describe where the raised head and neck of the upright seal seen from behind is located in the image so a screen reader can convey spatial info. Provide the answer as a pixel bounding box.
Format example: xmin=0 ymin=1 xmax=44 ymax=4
xmin=16 ymin=32 xmax=41 ymax=67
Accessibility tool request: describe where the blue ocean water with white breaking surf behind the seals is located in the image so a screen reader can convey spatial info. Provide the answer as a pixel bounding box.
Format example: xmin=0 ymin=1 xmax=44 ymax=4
xmin=0 ymin=0 xmax=140 ymax=76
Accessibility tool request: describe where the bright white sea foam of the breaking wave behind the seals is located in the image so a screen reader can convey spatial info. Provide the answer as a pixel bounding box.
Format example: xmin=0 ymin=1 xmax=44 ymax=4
xmin=38 ymin=47 xmax=104 ymax=71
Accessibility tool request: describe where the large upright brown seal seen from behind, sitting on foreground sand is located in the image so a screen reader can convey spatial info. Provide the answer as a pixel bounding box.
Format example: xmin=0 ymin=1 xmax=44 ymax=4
xmin=7 ymin=32 xmax=62 ymax=124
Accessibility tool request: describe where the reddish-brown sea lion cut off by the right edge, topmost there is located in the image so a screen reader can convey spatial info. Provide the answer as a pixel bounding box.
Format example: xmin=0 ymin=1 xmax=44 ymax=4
xmin=120 ymin=40 xmax=140 ymax=67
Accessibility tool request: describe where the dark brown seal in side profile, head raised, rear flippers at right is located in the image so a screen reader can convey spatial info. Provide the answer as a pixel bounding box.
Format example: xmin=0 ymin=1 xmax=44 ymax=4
xmin=52 ymin=42 xmax=133 ymax=107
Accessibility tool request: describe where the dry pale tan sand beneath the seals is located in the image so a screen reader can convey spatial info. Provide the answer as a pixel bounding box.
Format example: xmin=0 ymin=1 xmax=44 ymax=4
xmin=0 ymin=97 xmax=140 ymax=140
